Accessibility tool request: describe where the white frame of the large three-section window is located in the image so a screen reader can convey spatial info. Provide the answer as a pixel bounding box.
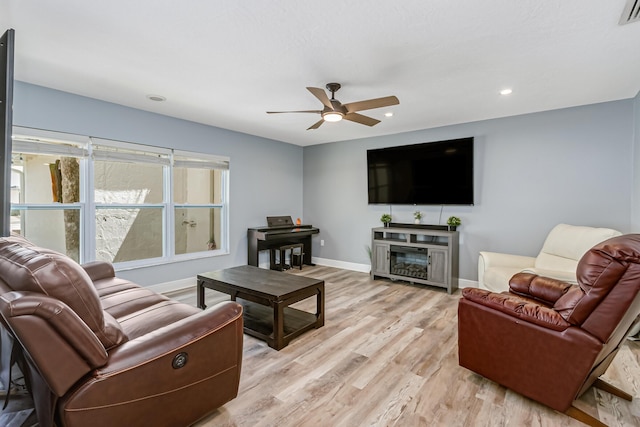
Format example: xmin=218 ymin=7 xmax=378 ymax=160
xmin=11 ymin=126 xmax=230 ymax=271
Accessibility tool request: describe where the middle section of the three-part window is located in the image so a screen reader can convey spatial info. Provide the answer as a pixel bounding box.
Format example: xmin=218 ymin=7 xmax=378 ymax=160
xmin=91 ymin=139 xmax=171 ymax=263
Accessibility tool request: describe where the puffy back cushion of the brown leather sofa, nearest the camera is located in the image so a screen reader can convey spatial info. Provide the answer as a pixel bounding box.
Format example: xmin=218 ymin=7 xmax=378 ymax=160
xmin=0 ymin=236 xmax=125 ymax=349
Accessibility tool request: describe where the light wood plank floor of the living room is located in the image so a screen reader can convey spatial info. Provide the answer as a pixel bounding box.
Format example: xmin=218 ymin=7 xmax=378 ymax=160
xmin=180 ymin=266 xmax=640 ymax=427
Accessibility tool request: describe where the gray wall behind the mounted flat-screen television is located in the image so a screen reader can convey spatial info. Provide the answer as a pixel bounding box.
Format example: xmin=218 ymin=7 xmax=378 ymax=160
xmin=304 ymin=99 xmax=640 ymax=280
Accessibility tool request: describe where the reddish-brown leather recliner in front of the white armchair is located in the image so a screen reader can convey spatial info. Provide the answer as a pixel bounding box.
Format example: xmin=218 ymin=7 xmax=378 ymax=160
xmin=458 ymin=234 xmax=640 ymax=425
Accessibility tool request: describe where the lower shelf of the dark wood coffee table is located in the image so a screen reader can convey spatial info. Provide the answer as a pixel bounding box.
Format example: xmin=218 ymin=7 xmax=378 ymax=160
xmin=236 ymin=298 xmax=321 ymax=348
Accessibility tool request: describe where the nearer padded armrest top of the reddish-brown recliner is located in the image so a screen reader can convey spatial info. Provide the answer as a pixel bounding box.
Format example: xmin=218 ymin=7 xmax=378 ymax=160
xmin=462 ymin=288 xmax=571 ymax=331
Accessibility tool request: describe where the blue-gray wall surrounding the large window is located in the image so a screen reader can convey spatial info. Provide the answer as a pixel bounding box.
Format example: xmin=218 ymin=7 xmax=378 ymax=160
xmin=13 ymin=82 xmax=303 ymax=285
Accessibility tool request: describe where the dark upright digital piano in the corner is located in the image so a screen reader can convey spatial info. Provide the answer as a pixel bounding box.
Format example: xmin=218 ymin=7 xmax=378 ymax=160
xmin=247 ymin=216 xmax=320 ymax=267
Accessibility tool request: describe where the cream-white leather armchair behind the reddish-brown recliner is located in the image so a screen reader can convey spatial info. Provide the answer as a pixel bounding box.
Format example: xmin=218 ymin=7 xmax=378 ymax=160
xmin=478 ymin=224 xmax=621 ymax=292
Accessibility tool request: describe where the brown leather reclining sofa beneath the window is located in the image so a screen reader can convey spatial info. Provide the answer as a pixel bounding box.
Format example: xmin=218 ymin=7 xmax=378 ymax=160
xmin=0 ymin=236 xmax=243 ymax=426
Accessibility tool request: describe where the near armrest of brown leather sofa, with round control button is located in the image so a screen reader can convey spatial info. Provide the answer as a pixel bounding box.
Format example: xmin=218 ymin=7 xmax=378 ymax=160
xmin=63 ymin=301 xmax=243 ymax=413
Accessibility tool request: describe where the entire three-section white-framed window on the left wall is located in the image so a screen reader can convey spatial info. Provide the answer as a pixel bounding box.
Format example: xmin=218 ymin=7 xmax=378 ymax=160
xmin=11 ymin=128 xmax=229 ymax=268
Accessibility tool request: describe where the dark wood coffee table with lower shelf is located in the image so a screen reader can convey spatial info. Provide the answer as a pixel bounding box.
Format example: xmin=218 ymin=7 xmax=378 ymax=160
xmin=197 ymin=265 xmax=324 ymax=350
